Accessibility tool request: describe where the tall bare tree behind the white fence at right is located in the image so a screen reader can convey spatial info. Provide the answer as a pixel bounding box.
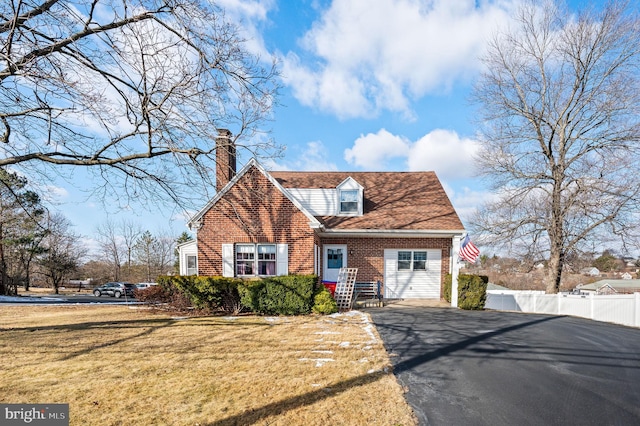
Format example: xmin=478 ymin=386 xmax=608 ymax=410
xmin=473 ymin=1 xmax=640 ymax=293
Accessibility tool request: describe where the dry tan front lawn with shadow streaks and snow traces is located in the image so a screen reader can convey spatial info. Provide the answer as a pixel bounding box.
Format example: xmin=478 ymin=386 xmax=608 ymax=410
xmin=0 ymin=306 xmax=415 ymax=425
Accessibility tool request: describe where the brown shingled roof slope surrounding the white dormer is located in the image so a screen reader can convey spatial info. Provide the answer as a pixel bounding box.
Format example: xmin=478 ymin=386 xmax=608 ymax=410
xmin=270 ymin=172 xmax=464 ymax=231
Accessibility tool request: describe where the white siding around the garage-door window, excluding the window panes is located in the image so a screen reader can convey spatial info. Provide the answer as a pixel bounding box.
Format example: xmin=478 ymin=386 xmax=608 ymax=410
xmin=384 ymin=248 xmax=442 ymax=299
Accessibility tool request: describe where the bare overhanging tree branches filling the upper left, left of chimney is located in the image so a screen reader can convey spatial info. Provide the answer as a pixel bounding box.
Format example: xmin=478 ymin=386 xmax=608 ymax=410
xmin=0 ymin=0 xmax=278 ymax=210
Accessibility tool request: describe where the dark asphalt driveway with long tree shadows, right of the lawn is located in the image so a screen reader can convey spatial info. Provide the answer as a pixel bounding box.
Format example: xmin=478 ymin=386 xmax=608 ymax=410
xmin=367 ymin=305 xmax=640 ymax=426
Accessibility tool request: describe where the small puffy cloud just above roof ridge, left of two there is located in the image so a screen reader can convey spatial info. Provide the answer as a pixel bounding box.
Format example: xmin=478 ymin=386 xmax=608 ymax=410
xmin=344 ymin=129 xmax=410 ymax=170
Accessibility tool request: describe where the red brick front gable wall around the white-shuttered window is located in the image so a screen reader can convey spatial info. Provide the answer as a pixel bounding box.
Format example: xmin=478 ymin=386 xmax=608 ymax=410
xmin=197 ymin=168 xmax=314 ymax=275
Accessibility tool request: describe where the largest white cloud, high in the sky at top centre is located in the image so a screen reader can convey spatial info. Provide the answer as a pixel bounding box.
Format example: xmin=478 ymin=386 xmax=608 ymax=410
xmin=283 ymin=0 xmax=516 ymax=118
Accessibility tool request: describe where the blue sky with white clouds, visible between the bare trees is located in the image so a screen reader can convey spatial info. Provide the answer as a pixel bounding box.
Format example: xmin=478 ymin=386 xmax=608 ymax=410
xmin=47 ymin=0 xmax=592 ymax=253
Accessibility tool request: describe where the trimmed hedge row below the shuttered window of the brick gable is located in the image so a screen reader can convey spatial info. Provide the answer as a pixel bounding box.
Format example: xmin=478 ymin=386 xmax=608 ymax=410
xmin=152 ymin=275 xmax=338 ymax=315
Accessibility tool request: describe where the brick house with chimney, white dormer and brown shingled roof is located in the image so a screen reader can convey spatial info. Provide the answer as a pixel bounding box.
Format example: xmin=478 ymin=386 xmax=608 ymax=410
xmin=178 ymin=131 xmax=464 ymax=304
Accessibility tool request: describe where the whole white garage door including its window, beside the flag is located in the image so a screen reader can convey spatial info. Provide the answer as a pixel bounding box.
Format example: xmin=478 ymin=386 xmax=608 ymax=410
xmin=384 ymin=249 xmax=442 ymax=299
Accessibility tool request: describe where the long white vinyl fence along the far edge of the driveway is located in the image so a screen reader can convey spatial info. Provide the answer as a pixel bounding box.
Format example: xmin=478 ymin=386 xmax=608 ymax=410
xmin=484 ymin=290 xmax=640 ymax=327
